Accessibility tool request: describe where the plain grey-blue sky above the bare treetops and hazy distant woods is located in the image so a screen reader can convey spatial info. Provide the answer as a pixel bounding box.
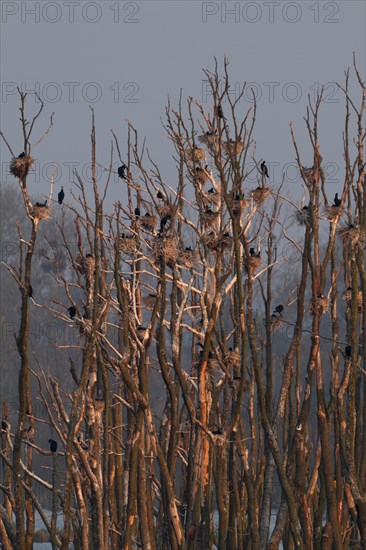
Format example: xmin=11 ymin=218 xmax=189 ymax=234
xmin=1 ymin=0 xmax=366 ymax=207
